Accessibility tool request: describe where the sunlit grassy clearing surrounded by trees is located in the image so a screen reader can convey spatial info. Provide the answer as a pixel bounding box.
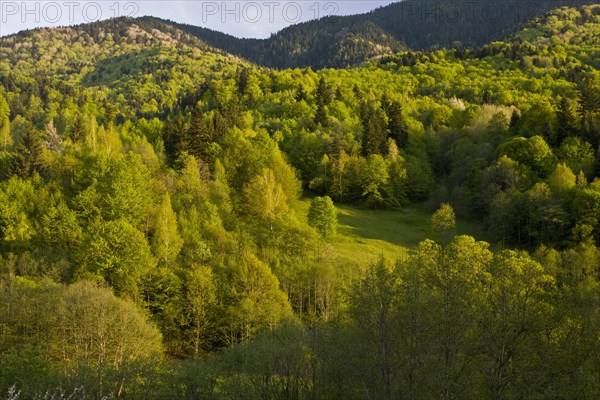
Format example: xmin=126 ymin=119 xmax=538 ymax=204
xmin=296 ymin=198 xmax=489 ymax=265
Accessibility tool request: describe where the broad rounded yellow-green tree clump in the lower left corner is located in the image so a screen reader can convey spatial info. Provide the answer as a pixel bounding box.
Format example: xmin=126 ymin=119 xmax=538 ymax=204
xmin=0 ymin=282 xmax=162 ymax=398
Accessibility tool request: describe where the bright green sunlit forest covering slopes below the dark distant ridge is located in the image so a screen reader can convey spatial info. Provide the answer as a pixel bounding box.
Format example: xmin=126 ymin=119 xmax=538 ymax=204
xmin=0 ymin=4 xmax=600 ymax=400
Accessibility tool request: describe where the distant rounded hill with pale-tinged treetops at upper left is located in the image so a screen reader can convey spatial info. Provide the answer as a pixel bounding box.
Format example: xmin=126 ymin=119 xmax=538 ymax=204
xmin=0 ymin=18 xmax=247 ymax=117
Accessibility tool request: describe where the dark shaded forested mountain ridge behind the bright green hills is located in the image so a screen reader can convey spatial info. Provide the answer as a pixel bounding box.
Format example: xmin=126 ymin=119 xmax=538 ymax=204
xmin=175 ymin=0 xmax=594 ymax=69
